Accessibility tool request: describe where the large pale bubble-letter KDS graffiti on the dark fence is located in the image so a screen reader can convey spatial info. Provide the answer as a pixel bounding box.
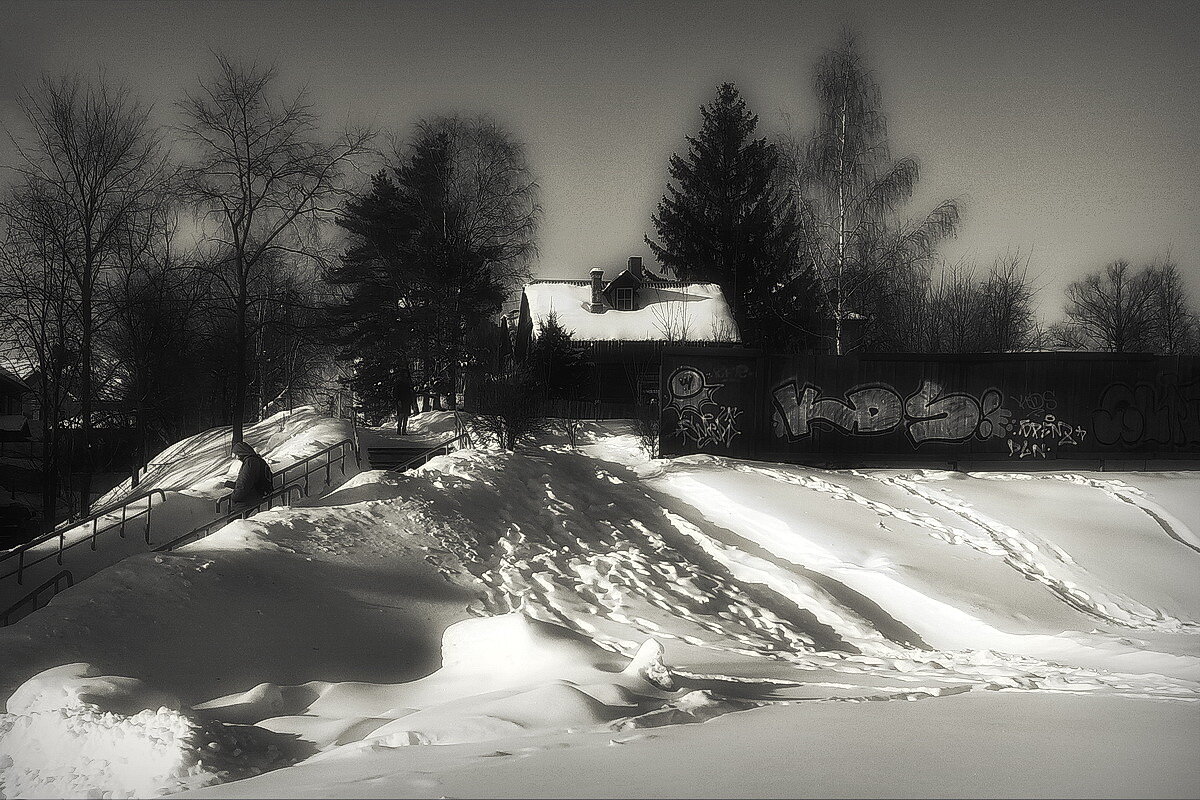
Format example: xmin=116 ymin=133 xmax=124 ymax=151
xmin=772 ymin=380 xmax=1012 ymax=446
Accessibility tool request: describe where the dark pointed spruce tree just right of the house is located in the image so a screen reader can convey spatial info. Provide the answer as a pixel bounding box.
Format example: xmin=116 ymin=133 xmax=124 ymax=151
xmin=646 ymin=83 xmax=809 ymax=347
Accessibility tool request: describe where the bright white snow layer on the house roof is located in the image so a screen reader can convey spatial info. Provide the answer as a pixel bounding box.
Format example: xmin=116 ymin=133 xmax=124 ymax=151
xmin=524 ymin=281 xmax=739 ymax=342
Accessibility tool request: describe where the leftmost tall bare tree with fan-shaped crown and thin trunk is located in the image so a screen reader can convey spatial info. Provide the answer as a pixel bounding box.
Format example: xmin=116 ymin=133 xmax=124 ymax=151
xmin=4 ymin=77 xmax=169 ymax=512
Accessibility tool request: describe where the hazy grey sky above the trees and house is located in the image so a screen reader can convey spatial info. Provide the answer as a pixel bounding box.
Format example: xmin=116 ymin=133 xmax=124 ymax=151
xmin=0 ymin=0 xmax=1200 ymax=317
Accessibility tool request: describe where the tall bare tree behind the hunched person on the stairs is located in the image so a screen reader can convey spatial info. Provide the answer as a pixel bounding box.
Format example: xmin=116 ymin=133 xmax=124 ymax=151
xmin=180 ymin=56 xmax=372 ymax=441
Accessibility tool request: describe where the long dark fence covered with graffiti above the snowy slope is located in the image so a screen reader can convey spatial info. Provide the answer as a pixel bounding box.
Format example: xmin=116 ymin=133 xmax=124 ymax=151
xmin=660 ymin=349 xmax=1200 ymax=462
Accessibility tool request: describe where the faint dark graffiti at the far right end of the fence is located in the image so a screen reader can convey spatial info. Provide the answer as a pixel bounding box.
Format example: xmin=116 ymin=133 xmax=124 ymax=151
xmin=1092 ymin=374 xmax=1200 ymax=446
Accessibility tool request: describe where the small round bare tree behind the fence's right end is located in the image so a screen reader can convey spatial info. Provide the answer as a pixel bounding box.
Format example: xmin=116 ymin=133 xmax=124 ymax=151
xmin=1063 ymin=259 xmax=1157 ymax=353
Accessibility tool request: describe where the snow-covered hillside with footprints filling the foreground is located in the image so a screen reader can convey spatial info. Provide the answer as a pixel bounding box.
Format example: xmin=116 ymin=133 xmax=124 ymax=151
xmin=0 ymin=421 xmax=1200 ymax=798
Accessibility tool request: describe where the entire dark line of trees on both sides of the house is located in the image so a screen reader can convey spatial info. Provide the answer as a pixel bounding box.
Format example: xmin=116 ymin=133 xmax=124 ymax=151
xmin=0 ymin=35 xmax=1198 ymax=524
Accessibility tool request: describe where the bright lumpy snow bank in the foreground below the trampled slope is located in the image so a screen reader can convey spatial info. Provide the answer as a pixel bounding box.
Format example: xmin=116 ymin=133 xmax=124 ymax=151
xmin=197 ymin=613 xmax=700 ymax=758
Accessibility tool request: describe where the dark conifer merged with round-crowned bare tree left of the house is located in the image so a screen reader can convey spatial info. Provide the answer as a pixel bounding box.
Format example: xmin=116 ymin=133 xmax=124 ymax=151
xmin=328 ymin=116 xmax=539 ymax=417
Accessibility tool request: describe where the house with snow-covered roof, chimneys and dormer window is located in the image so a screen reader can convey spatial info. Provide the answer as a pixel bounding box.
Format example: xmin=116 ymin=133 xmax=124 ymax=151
xmin=502 ymin=257 xmax=740 ymax=415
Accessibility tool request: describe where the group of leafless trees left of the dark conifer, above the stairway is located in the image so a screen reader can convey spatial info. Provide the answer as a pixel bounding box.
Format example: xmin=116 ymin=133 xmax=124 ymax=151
xmin=0 ymin=58 xmax=371 ymax=527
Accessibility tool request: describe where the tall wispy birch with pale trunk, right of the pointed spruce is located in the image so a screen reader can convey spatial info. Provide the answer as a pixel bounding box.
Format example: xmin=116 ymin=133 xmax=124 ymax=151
xmin=784 ymin=35 xmax=959 ymax=355
